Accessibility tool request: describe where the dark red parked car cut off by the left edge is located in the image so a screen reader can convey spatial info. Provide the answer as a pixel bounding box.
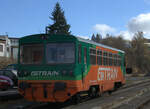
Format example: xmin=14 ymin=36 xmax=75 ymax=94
xmin=0 ymin=76 xmax=13 ymax=91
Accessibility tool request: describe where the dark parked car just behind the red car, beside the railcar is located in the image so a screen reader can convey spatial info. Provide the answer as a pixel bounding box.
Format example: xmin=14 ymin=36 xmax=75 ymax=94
xmin=0 ymin=69 xmax=18 ymax=86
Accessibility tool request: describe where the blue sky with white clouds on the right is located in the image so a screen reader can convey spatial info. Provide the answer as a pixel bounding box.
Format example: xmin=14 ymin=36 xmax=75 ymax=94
xmin=0 ymin=0 xmax=150 ymax=40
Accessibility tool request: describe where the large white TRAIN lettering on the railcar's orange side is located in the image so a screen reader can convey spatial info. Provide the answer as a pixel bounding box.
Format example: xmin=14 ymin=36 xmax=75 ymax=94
xmin=97 ymin=68 xmax=118 ymax=81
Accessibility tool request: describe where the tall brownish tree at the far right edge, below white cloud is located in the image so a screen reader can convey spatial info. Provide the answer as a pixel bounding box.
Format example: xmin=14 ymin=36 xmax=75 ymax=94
xmin=129 ymin=32 xmax=150 ymax=73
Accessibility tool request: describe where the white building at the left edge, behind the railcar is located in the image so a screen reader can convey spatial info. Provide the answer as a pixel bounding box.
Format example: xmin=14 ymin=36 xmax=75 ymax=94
xmin=0 ymin=35 xmax=19 ymax=59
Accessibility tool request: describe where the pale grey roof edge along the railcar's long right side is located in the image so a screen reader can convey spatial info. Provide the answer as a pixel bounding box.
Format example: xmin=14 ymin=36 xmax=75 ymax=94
xmin=77 ymin=37 xmax=125 ymax=53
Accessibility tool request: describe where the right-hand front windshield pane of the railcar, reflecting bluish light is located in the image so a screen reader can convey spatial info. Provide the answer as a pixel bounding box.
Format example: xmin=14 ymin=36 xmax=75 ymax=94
xmin=46 ymin=43 xmax=75 ymax=64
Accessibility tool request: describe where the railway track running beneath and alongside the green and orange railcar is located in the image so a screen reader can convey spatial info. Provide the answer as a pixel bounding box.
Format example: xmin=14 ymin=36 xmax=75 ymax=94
xmin=5 ymin=80 xmax=150 ymax=109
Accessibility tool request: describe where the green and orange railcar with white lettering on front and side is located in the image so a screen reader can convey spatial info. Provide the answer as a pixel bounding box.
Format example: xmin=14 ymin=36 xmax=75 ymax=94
xmin=18 ymin=34 xmax=126 ymax=102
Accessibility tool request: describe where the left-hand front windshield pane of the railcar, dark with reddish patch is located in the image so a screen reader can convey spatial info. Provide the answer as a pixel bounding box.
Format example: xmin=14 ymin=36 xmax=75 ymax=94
xmin=20 ymin=44 xmax=44 ymax=64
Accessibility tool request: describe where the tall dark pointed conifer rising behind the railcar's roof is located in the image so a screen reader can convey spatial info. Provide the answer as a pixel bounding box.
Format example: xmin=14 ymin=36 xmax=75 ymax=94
xmin=47 ymin=2 xmax=70 ymax=34
